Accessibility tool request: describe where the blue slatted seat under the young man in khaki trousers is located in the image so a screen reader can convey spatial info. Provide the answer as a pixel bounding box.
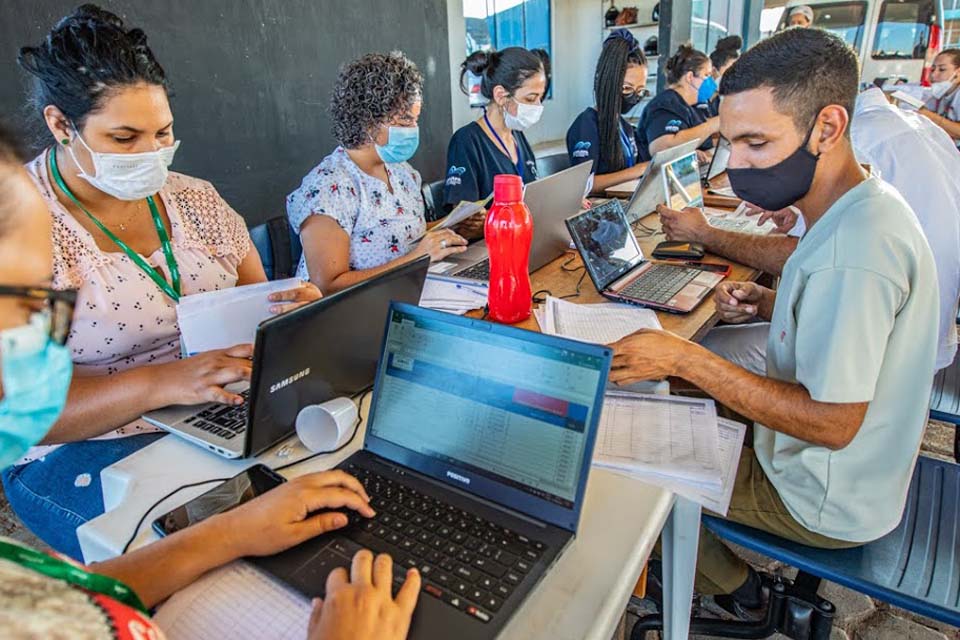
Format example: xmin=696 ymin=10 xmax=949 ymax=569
xmin=703 ymin=456 xmax=960 ymax=626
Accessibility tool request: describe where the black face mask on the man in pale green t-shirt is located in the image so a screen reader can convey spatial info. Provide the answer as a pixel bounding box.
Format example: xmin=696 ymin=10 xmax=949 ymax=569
xmin=727 ymin=123 xmax=820 ymax=211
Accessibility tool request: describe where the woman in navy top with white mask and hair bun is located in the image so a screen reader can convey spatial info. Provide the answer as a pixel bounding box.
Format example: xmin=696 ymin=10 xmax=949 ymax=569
xmin=443 ymin=47 xmax=547 ymax=218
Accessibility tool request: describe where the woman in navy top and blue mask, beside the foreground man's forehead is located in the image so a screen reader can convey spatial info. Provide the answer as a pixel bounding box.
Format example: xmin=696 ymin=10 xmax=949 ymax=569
xmin=637 ymin=44 xmax=720 ymax=156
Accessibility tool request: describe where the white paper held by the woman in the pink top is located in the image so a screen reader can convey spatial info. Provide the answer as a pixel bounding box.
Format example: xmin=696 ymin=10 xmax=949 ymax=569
xmin=177 ymin=278 xmax=300 ymax=356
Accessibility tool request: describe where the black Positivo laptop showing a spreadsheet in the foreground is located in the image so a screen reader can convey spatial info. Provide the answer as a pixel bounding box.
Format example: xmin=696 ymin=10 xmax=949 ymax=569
xmin=252 ymin=304 xmax=612 ymax=640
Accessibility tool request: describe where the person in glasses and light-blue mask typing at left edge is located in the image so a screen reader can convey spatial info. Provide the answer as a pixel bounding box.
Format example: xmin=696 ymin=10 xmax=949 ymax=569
xmin=0 ymin=120 xmax=420 ymax=640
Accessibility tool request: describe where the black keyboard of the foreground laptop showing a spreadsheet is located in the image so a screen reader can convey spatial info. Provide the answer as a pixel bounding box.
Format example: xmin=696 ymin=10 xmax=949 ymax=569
xmin=342 ymin=464 xmax=546 ymax=623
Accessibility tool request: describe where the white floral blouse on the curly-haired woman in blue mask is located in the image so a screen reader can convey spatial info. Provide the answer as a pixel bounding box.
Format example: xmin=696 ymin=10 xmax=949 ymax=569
xmin=287 ymin=147 xmax=426 ymax=279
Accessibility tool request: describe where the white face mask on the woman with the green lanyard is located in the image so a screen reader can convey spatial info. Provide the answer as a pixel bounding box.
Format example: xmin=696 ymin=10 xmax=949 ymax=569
xmin=67 ymin=129 xmax=180 ymax=200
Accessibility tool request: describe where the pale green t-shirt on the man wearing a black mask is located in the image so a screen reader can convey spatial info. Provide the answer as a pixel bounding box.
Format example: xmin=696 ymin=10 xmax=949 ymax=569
xmin=754 ymin=177 xmax=937 ymax=542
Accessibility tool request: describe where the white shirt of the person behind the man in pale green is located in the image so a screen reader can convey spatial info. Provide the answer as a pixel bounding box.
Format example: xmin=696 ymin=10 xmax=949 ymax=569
xmin=790 ymin=89 xmax=960 ymax=369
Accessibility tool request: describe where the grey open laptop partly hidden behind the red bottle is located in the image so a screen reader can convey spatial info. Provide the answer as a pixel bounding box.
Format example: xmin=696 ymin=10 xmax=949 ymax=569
xmin=443 ymin=160 xmax=593 ymax=281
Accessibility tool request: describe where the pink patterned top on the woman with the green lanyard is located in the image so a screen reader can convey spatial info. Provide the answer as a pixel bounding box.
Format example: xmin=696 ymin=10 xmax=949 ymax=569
xmin=27 ymin=152 xmax=250 ymax=456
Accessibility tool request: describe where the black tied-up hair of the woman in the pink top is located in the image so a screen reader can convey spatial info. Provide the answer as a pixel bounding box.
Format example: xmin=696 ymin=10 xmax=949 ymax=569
xmin=17 ymin=4 xmax=167 ymax=140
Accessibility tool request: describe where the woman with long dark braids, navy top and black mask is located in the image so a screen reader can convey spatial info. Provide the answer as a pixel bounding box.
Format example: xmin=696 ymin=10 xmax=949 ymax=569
xmin=567 ymin=29 xmax=650 ymax=194
